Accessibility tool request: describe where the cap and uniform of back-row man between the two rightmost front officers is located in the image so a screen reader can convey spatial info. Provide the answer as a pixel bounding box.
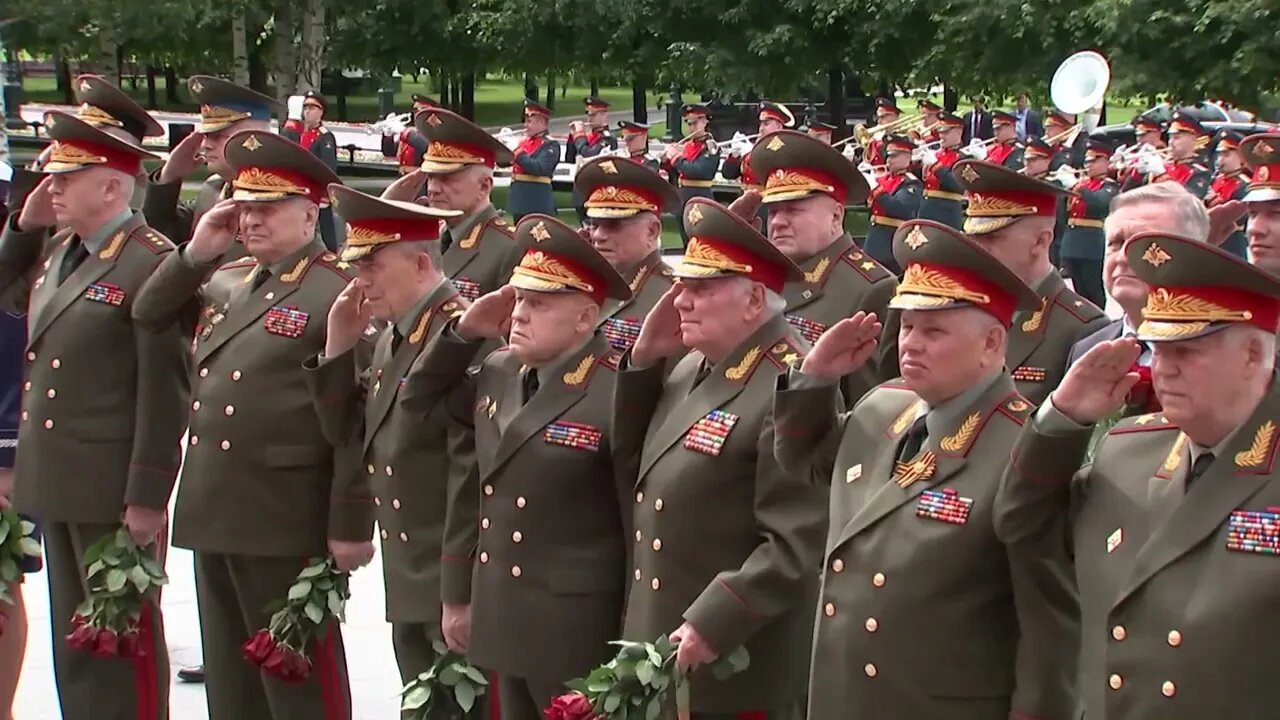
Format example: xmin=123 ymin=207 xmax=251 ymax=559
xmin=956 ymin=160 xmax=1108 ymax=405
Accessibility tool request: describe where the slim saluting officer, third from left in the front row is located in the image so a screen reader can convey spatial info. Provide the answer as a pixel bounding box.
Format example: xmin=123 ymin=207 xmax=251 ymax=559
xmin=303 ymin=184 xmax=477 ymax=683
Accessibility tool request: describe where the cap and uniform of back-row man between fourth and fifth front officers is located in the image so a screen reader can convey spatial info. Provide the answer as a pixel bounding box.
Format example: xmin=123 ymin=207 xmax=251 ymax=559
xmin=573 ymin=158 xmax=680 ymax=352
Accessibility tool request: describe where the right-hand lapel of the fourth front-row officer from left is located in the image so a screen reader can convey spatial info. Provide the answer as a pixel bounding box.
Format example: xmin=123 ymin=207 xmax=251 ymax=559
xmin=485 ymin=333 xmax=609 ymax=475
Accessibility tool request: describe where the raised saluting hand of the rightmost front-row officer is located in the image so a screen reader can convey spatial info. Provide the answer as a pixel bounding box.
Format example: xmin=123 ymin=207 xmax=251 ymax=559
xmin=1050 ymin=337 xmax=1142 ymax=425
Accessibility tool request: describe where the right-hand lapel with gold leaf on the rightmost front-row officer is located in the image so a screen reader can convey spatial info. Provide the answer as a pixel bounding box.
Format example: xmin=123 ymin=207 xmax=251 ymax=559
xmin=1114 ymin=384 xmax=1280 ymax=607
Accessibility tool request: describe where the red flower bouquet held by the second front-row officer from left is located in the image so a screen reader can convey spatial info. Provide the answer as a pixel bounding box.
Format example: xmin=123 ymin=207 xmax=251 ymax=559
xmin=241 ymin=557 xmax=351 ymax=683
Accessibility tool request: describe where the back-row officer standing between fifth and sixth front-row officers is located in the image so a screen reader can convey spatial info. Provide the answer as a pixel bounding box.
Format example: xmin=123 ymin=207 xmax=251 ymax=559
xmin=733 ymin=131 xmax=897 ymax=402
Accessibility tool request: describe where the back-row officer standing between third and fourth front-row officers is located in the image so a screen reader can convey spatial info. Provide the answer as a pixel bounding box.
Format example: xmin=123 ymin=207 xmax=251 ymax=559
xmin=415 ymin=109 xmax=520 ymax=301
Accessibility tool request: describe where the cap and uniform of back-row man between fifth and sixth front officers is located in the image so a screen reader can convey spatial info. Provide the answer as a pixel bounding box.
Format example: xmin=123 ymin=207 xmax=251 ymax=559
xmin=751 ymin=129 xmax=897 ymax=404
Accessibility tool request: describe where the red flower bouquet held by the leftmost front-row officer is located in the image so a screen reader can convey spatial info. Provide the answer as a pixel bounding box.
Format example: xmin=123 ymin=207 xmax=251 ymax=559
xmin=67 ymin=527 xmax=169 ymax=657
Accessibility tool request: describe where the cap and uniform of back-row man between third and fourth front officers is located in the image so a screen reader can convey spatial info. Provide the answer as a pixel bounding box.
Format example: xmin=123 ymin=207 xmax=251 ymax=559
xmin=415 ymin=108 xmax=520 ymax=301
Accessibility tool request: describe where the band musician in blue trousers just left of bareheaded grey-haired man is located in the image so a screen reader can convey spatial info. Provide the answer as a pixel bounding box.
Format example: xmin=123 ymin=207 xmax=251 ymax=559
xmin=1061 ymin=140 xmax=1120 ymax=307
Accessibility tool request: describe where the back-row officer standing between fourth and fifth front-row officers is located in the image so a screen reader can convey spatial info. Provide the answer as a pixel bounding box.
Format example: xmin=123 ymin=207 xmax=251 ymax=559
xmin=573 ymin=158 xmax=680 ymax=352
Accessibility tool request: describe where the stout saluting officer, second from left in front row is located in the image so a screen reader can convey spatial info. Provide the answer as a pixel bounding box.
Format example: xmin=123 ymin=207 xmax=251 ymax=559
xmin=133 ymin=131 xmax=374 ymax=720
